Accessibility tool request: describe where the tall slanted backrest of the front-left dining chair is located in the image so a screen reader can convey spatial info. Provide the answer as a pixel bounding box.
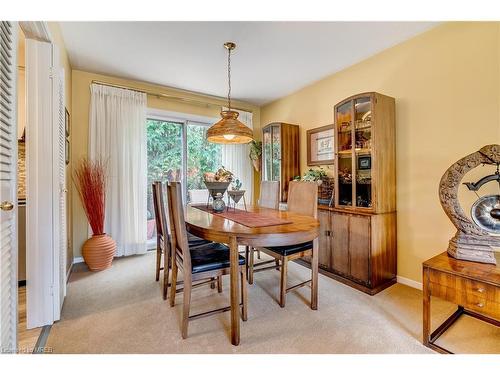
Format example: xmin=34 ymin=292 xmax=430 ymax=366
xmin=167 ymin=182 xmax=191 ymax=271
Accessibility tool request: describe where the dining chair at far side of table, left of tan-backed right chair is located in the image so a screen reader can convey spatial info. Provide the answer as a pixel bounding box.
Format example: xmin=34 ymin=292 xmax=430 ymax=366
xmin=245 ymin=181 xmax=280 ymax=284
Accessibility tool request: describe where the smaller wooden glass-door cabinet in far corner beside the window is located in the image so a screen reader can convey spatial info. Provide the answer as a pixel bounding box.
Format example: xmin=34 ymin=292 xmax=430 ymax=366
xmin=262 ymin=122 xmax=300 ymax=202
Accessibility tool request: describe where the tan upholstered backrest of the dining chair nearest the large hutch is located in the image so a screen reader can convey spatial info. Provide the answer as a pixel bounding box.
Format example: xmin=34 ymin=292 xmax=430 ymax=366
xmin=287 ymin=181 xmax=318 ymax=219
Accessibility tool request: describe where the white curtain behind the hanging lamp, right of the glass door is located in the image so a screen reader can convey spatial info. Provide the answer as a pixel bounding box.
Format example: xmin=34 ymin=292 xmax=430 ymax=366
xmin=222 ymin=108 xmax=253 ymax=204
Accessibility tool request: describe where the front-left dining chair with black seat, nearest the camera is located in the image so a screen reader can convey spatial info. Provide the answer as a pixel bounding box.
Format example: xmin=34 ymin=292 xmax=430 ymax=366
xmin=168 ymin=182 xmax=247 ymax=339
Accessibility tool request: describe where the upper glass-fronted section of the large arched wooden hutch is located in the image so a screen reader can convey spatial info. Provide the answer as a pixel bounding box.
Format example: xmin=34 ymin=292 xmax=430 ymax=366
xmin=334 ymin=93 xmax=396 ymax=213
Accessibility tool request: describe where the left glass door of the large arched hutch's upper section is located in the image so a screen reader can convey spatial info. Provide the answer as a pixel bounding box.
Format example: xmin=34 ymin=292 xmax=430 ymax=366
xmin=335 ymin=101 xmax=353 ymax=206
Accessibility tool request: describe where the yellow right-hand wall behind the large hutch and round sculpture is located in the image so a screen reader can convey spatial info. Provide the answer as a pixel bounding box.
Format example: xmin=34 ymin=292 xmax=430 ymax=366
xmin=261 ymin=23 xmax=500 ymax=281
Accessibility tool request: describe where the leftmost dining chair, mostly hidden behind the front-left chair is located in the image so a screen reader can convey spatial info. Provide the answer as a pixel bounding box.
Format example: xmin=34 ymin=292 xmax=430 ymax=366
xmin=151 ymin=181 xmax=210 ymax=300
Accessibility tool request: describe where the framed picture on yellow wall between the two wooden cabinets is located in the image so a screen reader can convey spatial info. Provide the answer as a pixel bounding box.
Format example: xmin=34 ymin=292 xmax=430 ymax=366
xmin=307 ymin=124 xmax=335 ymax=165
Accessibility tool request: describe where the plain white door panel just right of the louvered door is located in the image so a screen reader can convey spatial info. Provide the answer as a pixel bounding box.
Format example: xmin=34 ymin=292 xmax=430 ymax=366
xmin=26 ymin=39 xmax=66 ymax=328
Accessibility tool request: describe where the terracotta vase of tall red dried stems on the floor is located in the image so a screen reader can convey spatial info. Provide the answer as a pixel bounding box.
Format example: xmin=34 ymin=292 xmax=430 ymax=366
xmin=73 ymin=158 xmax=116 ymax=271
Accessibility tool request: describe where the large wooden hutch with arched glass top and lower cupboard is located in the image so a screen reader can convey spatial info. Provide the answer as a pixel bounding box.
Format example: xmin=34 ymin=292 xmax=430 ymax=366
xmin=302 ymin=92 xmax=397 ymax=295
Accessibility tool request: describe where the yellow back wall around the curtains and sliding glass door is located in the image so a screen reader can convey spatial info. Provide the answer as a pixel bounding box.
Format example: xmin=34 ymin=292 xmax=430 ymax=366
xmin=71 ymin=70 xmax=260 ymax=256
